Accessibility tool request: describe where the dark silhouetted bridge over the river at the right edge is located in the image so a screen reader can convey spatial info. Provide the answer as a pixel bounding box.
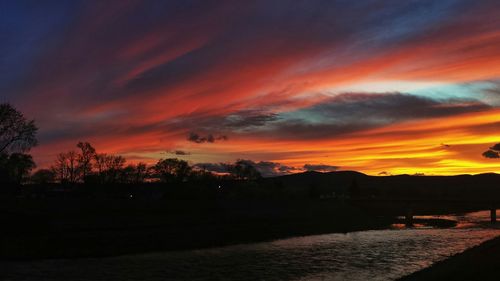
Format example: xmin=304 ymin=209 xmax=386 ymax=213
xmin=349 ymin=198 xmax=500 ymax=225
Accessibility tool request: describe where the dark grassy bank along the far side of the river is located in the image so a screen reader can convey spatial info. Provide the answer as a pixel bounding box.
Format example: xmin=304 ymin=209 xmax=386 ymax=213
xmin=0 ymin=199 xmax=391 ymax=260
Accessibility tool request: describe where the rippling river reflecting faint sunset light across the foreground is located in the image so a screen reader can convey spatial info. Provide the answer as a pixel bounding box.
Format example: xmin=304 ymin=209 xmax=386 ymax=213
xmin=0 ymin=212 xmax=500 ymax=281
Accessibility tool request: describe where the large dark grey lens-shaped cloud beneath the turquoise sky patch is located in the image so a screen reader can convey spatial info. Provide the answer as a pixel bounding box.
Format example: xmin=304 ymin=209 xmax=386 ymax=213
xmin=262 ymin=93 xmax=490 ymax=138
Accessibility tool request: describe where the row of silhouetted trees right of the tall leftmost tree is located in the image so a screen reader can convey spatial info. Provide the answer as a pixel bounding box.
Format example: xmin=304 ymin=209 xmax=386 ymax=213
xmin=32 ymin=142 xmax=261 ymax=184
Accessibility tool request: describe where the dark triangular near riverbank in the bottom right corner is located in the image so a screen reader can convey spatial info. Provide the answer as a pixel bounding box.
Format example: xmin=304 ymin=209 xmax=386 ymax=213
xmin=399 ymin=233 xmax=500 ymax=281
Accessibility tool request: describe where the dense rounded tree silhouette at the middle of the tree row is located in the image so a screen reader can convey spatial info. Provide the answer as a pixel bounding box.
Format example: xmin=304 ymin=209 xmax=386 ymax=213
xmin=153 ymin=158 xmax=191 ymax=183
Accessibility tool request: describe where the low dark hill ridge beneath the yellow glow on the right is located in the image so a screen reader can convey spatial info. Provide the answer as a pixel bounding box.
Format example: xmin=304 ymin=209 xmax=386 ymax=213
xmin=257 ymin=171 xmax=500 ymax=199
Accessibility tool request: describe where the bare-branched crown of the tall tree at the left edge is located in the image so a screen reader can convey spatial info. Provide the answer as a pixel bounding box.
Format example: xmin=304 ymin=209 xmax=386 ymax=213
xmin=0 ymin=103 xmax=37 ymax=154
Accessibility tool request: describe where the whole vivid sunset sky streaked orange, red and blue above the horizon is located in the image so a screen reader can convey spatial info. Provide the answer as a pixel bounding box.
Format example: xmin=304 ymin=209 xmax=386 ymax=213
xmin=0 ymin=0 xmax=500 ymax=175
